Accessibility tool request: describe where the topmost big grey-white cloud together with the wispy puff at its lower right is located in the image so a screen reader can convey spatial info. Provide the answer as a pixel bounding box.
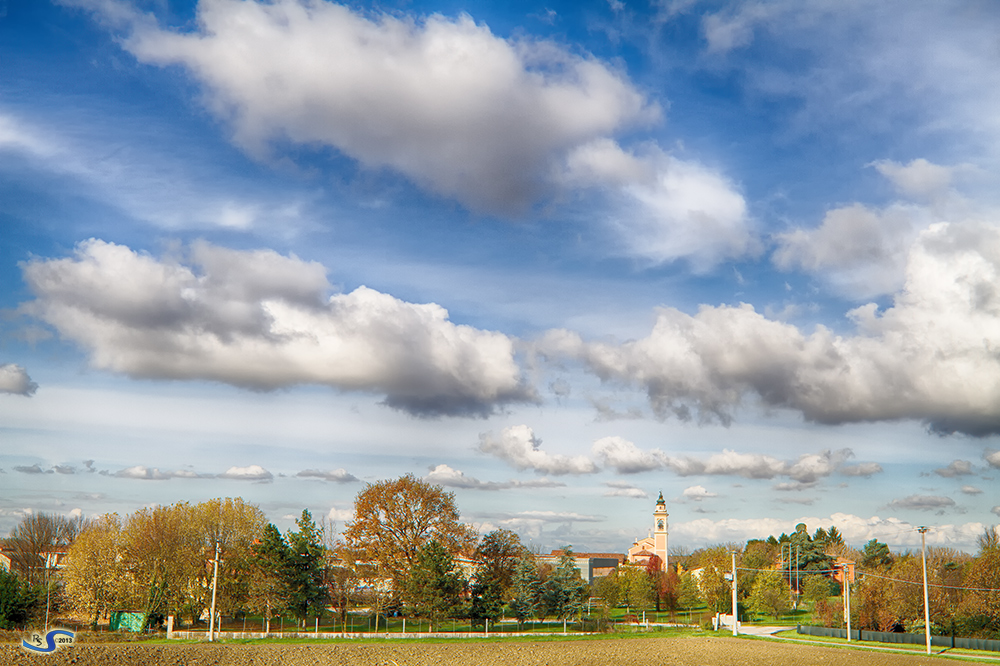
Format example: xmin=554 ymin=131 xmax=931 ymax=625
xmin=72 ymin=0 xmax=758 ymax=269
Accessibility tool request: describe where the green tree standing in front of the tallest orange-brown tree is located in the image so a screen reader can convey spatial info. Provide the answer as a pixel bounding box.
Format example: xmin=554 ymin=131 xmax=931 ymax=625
xmin=406 ymin=541 xmax=465 ymax=626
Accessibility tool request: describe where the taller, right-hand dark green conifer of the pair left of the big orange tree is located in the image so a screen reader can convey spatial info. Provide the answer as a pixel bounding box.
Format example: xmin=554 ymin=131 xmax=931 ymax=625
xmin=285 ymin=509 xmax=328 ymax=622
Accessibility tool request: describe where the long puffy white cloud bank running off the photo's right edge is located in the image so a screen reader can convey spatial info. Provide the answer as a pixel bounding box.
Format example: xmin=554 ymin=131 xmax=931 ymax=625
xmin=539 ymin=223 xmax=1000 ymax=436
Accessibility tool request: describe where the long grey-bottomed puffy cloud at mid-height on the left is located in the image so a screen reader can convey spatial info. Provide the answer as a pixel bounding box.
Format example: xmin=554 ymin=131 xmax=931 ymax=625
xmin=23 ymin=239 xmax=535 ymax=416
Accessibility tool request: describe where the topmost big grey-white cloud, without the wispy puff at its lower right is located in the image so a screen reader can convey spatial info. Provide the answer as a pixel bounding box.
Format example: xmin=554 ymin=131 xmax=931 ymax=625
xmin=117 ymin=0 xmax=659 ymax=211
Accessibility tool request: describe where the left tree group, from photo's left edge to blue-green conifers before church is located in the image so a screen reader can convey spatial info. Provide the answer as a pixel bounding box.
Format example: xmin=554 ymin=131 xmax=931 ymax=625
xmin=0 ymin=475 xmax=589 ymax=631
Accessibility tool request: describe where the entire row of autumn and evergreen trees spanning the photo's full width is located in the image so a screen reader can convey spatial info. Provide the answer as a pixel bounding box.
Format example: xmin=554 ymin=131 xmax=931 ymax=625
xmin=0 ymin=482 xmax=1000 ymax=638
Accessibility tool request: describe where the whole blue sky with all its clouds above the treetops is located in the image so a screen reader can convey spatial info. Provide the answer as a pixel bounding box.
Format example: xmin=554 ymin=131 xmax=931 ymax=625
xmin=0 ymin=0 xmax=1000 ymax=552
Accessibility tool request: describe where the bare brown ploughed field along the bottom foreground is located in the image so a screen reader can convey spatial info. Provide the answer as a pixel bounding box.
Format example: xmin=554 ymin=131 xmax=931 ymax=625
xmin=0 ymin=637 xmax=944 ymax=666
